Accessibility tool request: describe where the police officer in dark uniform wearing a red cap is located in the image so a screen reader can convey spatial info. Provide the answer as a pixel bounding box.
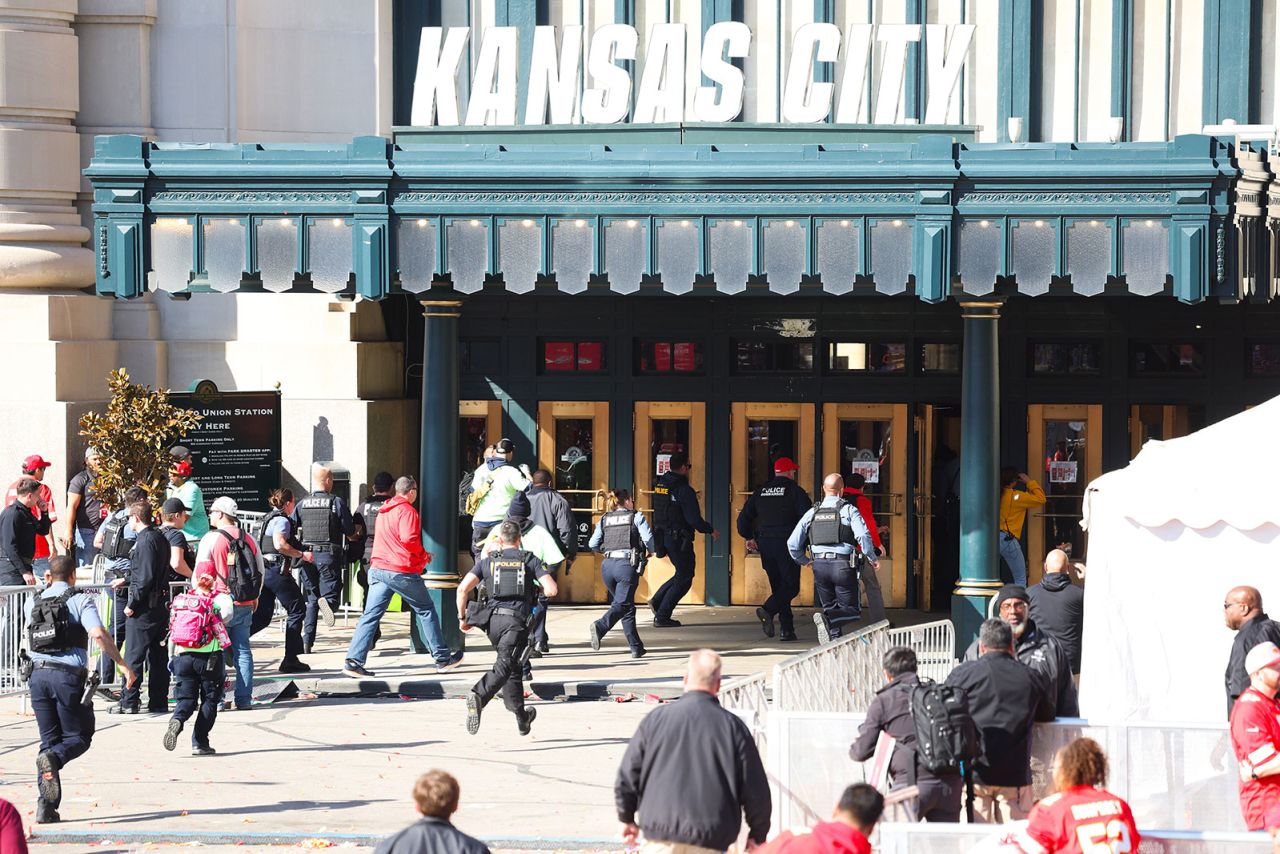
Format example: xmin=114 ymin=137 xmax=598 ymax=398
xmin=737 ymin=457 xmax=813 ymax=640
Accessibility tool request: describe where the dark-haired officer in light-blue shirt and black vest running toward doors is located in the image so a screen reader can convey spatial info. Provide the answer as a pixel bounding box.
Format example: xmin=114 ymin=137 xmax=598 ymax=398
xmin=588 ymin=489 xmax=653 ymax=658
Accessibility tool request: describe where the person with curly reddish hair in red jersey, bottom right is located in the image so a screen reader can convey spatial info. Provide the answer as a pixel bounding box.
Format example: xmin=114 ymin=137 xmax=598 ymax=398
xmin=1018 ymin=739 xmax=1142 ymax=854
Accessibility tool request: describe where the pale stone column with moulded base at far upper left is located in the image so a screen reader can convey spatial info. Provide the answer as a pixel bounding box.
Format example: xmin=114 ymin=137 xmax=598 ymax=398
xmin=0 ymin=0 xmax=93 ymax=291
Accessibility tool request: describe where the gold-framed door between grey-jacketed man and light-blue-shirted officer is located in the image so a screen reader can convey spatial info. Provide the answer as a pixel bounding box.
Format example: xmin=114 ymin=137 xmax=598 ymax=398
xmin=538 ymin=401 xmax=609 ymax=603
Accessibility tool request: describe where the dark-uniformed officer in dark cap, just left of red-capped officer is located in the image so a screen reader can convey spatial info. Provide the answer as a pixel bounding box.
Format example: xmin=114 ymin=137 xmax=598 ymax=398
xmin=649 ymin=451 xmax=719 ymax=629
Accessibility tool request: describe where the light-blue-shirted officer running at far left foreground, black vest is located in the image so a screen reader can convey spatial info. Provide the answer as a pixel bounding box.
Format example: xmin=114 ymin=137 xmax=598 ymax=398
xmin=27 ymin=554 xmax=138 ymax=825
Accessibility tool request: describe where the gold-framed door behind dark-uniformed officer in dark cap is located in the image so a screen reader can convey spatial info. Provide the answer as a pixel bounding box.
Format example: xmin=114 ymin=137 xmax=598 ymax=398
xmin=631 ymin=401 xmax=707 ymax=604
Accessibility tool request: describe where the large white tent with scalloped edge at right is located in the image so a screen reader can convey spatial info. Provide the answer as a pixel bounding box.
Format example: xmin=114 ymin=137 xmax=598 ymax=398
xmin=1080 ymin=398 xmax=1280 ymax=723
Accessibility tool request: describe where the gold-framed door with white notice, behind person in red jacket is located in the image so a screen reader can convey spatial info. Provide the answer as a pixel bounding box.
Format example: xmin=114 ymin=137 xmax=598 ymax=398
xmin=822 ymin=403 xmax=909 ymax=608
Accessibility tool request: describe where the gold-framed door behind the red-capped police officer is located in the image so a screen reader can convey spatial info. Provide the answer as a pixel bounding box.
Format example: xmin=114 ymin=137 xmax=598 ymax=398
xmin=730 ymin=403 xmax=814 ymax=606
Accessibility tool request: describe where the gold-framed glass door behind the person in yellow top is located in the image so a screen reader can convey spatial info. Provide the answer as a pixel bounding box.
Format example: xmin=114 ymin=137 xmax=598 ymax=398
xmin=1027 ymin=403 xmax=1102 ymax=584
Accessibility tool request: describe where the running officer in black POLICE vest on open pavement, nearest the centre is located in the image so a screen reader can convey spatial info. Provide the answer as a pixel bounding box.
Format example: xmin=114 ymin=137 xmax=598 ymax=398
xmin=457 ymin=521 xmax=558 ymax=735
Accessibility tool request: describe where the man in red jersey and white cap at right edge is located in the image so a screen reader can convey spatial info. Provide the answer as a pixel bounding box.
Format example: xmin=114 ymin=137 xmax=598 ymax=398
xmin=1231 ymin=640 xmax=1280 ymax=830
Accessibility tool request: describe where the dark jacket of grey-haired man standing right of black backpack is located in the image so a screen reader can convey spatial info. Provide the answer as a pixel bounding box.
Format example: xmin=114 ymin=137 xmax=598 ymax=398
xmin=947 ymin=652 xmax=1053 ymax=786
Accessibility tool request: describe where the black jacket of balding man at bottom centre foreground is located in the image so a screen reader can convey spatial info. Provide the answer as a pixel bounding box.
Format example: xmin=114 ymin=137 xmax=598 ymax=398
xmin=613 ymin=691 xmax=773 ymax=851
